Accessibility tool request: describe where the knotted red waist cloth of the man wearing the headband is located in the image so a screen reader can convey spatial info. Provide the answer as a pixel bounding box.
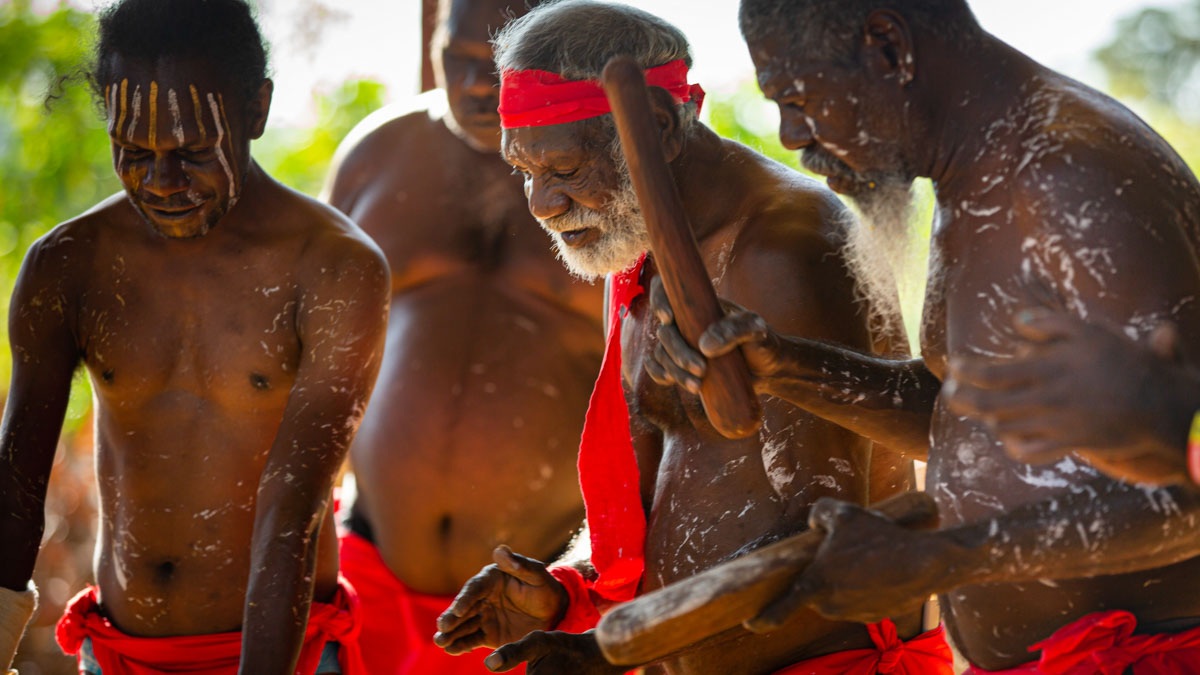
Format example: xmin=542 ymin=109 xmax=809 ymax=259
xmin=775 ymin=619 xmax=954 ymax=675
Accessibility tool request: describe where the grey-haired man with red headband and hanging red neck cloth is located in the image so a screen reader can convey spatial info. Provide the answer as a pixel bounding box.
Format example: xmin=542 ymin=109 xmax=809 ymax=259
xmin=437 ymin=0 xmax=950 ymax=675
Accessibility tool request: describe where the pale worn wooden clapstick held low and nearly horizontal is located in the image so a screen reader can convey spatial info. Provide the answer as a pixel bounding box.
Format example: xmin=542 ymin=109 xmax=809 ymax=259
xmin=596 ymin=492 xmax=937 ymax=665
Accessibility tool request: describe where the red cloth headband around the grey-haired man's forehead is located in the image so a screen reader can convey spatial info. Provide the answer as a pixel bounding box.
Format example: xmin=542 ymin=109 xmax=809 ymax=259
xmin=499 ymin=59 xmax=704 ymax=129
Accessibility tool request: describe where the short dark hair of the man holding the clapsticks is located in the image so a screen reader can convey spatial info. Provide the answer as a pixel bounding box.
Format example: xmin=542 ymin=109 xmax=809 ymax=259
xmin=739 ymin=0 xmax=983 ymax=65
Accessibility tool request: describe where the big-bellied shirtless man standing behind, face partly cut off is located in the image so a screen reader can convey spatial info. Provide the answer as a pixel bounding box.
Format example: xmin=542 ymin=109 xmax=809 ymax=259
xmin=328 ymin=0 xmax=604 ymax=675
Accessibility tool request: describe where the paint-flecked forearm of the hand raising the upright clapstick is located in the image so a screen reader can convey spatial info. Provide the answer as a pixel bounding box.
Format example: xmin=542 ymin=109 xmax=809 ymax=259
xmin=763 ymin=338 xmax=942 ymax=459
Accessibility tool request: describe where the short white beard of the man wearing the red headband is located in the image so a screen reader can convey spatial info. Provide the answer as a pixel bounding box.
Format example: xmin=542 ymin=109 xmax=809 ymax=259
xmin=538 ymin=143 xmax=650 ymax=281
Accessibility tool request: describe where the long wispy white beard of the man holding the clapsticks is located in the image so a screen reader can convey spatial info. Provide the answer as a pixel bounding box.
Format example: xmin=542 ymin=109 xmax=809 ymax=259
xmin=845 ymin=175 xmax=917 ymax=336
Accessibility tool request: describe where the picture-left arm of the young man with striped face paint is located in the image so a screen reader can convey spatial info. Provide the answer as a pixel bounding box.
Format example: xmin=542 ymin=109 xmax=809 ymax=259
xmin=0 ymin=233 xmax=79 ymax=589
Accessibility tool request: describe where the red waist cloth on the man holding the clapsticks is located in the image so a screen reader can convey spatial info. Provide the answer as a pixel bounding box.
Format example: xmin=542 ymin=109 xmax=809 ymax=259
xmin=967 ymin=610 xmax=1200 ymax=675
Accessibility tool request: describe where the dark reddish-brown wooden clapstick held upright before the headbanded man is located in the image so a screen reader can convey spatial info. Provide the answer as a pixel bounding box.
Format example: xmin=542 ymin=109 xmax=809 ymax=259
xmin=601 ymin=56 xmax=762 ymax=438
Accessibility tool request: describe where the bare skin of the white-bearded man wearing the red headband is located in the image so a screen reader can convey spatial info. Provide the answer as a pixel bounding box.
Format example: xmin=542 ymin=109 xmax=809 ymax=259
xmin=439 ymin=81 xmax=919 ymax=675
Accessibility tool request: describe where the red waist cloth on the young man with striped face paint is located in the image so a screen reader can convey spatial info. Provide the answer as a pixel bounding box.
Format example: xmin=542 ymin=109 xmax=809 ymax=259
xmin=55 ymin=578 xmax=368 ymax=675
